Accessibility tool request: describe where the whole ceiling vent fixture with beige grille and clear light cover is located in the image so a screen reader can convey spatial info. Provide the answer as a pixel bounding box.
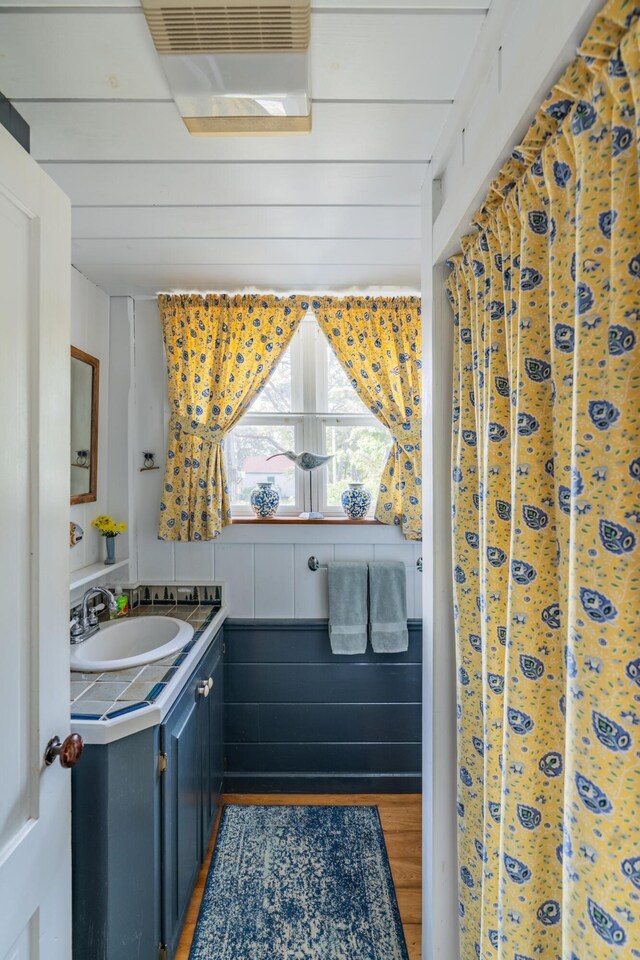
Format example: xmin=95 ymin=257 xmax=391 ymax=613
xmin=142 ymin=0 xmax=311 ymax=135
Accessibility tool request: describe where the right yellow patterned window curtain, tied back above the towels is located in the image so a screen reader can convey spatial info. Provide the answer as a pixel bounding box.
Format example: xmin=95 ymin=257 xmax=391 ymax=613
xmin=312 ymin=297 xmax=422 ymax=540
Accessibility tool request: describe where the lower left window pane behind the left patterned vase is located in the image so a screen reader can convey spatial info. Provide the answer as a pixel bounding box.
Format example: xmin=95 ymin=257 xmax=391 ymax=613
xmin=224 ymin=423 xmax=296 ymax=506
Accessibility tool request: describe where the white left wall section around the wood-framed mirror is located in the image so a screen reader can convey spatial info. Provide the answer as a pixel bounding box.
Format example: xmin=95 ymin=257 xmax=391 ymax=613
xmin=69 ymin=267 xmax=109 ymax=571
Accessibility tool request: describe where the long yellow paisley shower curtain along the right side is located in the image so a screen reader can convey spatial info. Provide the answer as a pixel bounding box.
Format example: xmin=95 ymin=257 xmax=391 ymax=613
xmin=448 ymin=0 xmax=640 ymax=960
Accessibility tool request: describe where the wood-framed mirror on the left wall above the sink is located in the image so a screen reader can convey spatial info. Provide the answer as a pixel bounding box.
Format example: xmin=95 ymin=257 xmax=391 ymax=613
xmin=71 ymin=347 xmax=100 ymax=503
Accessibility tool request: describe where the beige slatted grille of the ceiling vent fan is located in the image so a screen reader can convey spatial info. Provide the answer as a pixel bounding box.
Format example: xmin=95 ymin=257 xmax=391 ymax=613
xmin=143 ymin=0 xmax=310 ymax=55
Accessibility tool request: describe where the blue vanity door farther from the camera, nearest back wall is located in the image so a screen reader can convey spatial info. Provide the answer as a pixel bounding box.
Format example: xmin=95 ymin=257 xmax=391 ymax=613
xmin=201 ymin=634 xmax=224 ymax=857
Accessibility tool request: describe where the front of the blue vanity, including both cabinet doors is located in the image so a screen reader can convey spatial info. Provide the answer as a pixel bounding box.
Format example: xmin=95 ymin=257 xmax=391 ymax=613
xmin=160 ymin=631 xmax=223 ymax=958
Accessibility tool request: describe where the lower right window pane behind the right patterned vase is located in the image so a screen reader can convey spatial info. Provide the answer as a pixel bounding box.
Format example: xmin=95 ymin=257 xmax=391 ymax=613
xmin=325 ymin=424 xmax=391 ymax=510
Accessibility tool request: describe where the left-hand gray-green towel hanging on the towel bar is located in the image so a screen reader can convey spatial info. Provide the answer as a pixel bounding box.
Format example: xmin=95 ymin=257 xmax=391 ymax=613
xmin=328 ymin=561 xmax=367 ymax=654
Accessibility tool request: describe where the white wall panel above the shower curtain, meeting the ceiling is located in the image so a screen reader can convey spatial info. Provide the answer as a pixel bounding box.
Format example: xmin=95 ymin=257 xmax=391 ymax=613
xmin=431 ymin=0 xmax=602 ymax=262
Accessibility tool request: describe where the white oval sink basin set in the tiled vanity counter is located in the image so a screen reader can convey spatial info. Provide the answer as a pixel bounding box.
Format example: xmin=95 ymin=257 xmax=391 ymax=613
xmin=71 ymin=617 xmax=193 ymax=673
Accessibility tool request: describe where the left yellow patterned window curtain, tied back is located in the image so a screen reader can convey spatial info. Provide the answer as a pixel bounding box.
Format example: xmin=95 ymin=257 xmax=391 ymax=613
xmin=158 ymin=294 xmax=309 ymax=540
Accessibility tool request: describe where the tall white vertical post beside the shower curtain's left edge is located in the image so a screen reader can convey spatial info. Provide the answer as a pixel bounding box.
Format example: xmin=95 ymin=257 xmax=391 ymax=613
xmin=422 ymin=179 xmax=459 ymax=960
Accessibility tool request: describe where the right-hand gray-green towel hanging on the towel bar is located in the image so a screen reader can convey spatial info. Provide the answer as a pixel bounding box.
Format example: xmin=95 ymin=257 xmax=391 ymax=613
xmin=369 ymin=560 xmax=409 ymax=653
